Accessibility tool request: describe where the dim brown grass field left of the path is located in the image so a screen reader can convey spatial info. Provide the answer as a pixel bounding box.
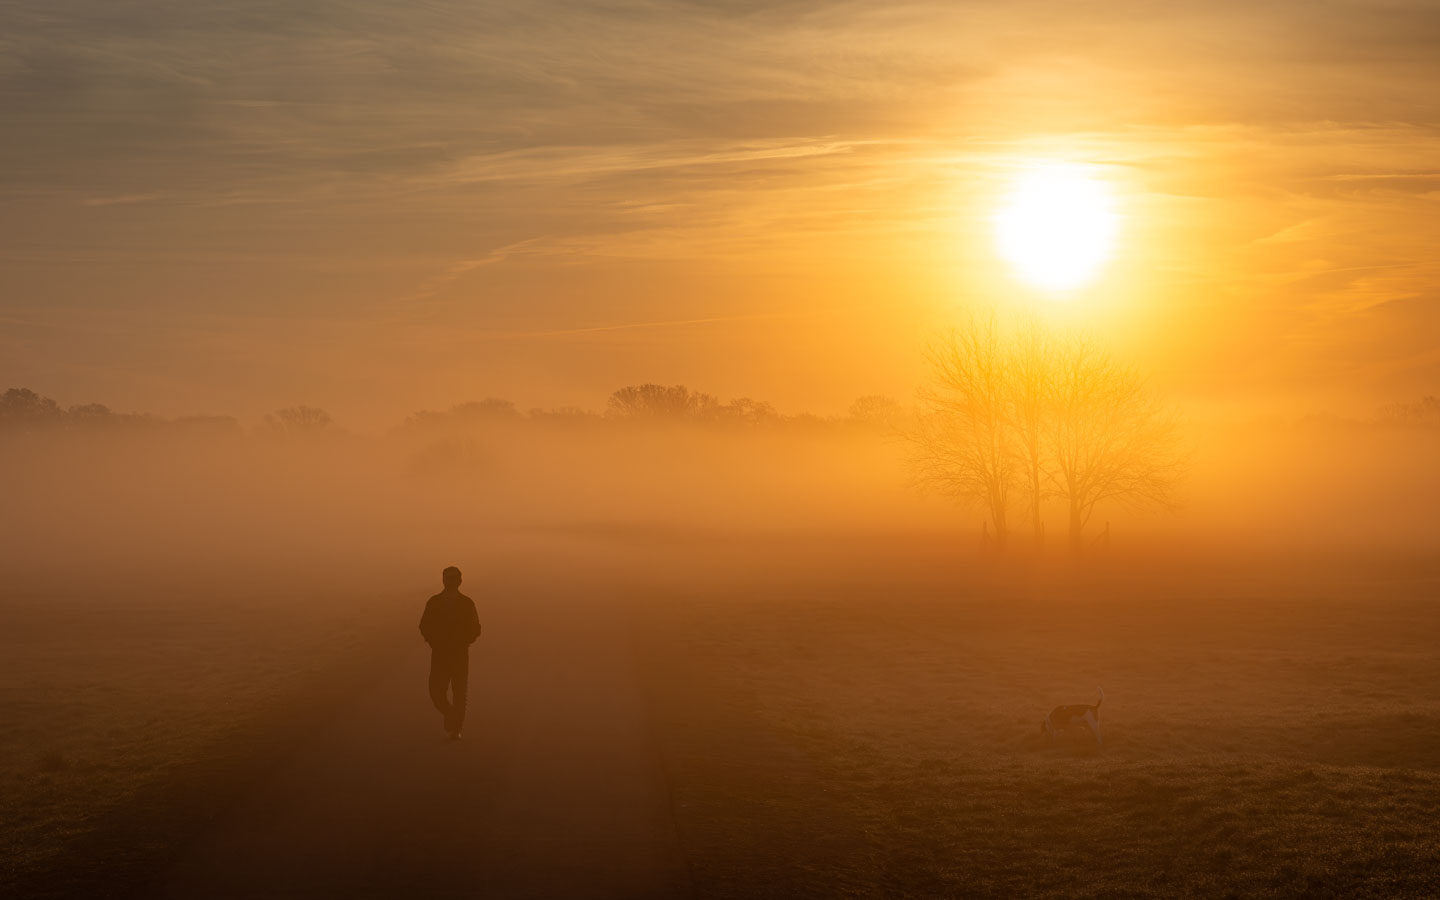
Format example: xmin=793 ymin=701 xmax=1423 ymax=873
xmin=0 ymin=573 xmax=397 ymax=896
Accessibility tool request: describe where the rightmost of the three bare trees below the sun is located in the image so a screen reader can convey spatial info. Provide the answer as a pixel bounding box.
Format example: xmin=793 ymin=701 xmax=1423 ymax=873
xmin=1045 ymin=338 xmax=1184 ymax=552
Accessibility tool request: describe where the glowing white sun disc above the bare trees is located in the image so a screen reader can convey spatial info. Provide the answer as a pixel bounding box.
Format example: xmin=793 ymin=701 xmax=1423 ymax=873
xmin=994 ymin=163 xmax=1120 ymax=297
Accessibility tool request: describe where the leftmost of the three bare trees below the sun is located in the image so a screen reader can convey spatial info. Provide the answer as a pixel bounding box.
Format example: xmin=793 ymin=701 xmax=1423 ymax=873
xmin=907 ymin=320 xmax=1017 ymax=552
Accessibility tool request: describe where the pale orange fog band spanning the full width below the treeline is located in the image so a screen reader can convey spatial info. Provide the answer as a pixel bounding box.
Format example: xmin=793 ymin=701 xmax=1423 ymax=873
xmin=0 ymin=397 xmax=1440 ymax=590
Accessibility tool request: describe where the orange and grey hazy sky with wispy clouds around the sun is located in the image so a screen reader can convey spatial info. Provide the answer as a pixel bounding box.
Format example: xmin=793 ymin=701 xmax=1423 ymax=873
xmin=0 ymin=0 xmax=1440 ymax=428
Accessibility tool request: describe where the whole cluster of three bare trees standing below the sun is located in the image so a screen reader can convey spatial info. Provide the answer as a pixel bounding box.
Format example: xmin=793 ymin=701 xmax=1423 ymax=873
xmin=907 ymin=318 xmax=1184 ymax=550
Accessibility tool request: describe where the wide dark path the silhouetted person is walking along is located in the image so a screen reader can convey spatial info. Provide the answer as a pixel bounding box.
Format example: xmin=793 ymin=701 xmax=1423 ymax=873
xmin=158 ymin=598 xmax=690 ymax=899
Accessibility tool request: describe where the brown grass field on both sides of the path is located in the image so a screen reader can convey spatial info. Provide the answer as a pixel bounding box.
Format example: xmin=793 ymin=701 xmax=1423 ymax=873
xmin=0 ymin=544 xmax=1440 ymax=899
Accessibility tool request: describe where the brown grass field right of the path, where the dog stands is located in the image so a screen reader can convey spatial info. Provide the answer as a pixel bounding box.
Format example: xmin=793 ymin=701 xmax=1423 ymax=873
xmin=645 ymin=550 xmax=1440 ymax=899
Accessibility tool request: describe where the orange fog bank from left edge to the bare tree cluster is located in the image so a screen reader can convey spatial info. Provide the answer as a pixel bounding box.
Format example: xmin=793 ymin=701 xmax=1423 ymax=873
xmin=0 ymin=422 xmax=915 ymax=581
